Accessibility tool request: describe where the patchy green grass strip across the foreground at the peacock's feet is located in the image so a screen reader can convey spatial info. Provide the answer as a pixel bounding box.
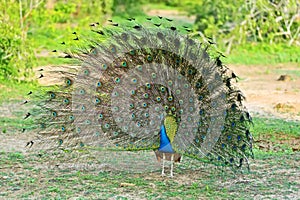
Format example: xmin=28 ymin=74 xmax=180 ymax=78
xmin=0 ymin=151 xmax=300 ymax=199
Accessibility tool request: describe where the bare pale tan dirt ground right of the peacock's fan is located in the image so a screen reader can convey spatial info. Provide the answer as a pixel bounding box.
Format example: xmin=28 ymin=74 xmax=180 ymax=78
xmin=229 ymin=64 xmax=300 ymax=120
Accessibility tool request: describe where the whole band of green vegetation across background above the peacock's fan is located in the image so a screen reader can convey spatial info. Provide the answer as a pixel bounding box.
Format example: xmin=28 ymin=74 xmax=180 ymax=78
xmin=0 ymin=0 xmax=300 ymax=80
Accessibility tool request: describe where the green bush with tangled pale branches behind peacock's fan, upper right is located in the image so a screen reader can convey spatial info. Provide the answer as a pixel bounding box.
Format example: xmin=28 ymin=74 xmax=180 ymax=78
xmin=191 ymin=0 xmax=300 ymax=48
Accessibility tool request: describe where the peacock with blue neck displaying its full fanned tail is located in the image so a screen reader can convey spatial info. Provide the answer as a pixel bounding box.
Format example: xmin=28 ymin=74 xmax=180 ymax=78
xmin=25 ymin=17 xmax=253 ymax=177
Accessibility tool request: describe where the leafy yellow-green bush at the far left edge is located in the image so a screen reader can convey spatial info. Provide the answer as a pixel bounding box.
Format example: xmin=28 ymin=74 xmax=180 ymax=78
xmin=0 ymin=0 xmax=35 ymax=80
